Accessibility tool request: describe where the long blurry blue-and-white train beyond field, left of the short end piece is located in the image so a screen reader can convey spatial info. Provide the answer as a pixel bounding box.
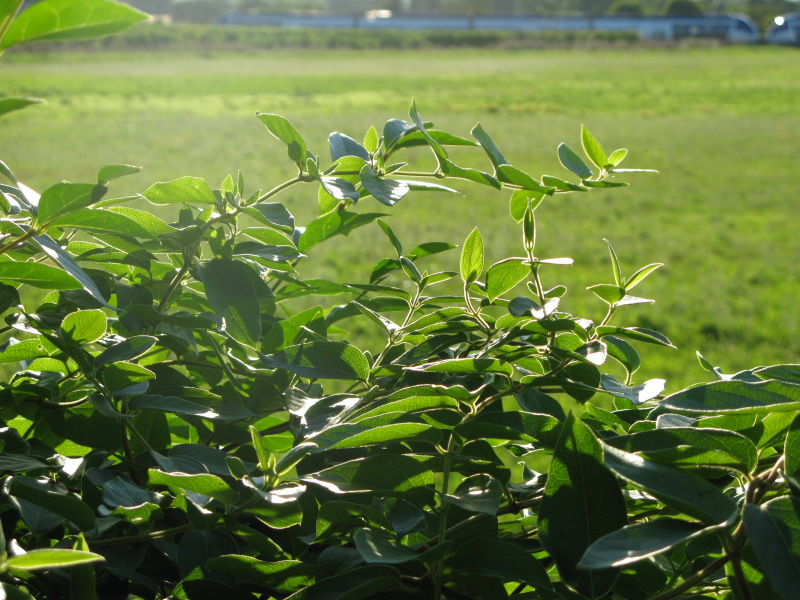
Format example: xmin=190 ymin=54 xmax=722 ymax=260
xmin=220 ymin=11 xmax=761 ymax=44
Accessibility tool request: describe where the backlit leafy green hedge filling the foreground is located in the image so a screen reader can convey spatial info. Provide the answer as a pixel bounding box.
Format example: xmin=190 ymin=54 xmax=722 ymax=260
xmin=0 ymin=0 xmax=800 ymax=600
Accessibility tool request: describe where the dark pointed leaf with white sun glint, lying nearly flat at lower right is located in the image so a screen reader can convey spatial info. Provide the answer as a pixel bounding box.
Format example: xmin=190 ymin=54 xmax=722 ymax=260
xmin=578 ymin=518 xmax=710 ymax=570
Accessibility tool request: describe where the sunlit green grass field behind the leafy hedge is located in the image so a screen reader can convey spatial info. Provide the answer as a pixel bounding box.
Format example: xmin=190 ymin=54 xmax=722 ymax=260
xmin=0 ymin=47 xmax=800 ymax=389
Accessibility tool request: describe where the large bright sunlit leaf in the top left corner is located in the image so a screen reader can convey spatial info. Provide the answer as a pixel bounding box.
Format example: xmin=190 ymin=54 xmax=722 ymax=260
xmin=0 ymin=0 xmax=147 ymax=50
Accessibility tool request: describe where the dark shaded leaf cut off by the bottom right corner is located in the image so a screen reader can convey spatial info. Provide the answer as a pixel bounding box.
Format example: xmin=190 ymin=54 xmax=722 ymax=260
xmin=743 ymin=496 xmax=800 ymax=600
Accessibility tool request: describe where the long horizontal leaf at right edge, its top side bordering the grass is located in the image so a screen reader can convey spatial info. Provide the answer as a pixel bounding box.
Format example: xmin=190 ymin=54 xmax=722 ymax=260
xmin=660 ymin=380 xmax=800 ymax=414
